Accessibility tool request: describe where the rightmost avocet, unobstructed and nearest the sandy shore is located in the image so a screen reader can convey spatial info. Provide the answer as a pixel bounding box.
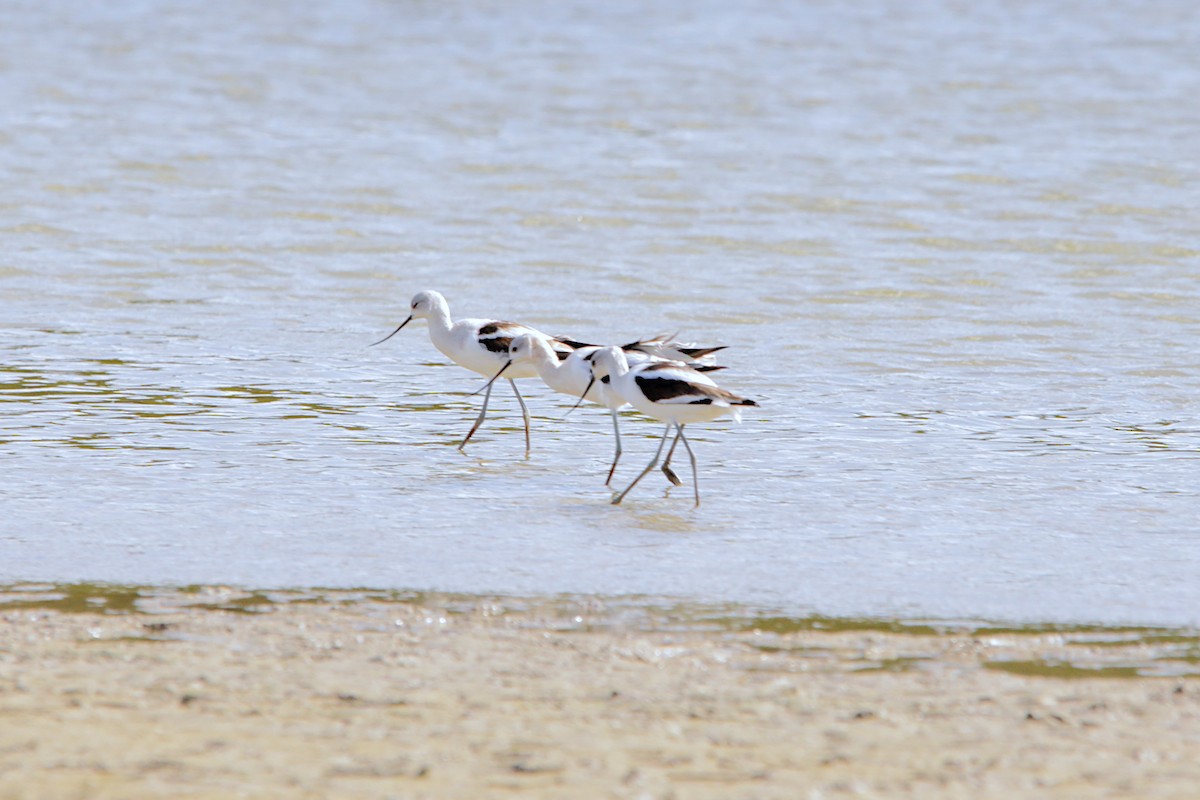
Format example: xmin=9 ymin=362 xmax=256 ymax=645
xmin=590 ymin=347 xmax=757 ymax=506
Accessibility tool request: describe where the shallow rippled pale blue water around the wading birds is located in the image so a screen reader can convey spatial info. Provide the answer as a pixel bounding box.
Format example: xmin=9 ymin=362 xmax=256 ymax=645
xmin=0 ymin=0 xmax=1200 ymax=625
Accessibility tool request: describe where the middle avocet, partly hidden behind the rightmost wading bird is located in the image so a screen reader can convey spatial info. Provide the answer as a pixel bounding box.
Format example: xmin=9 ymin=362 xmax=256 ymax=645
xmin=472 ymin=333 xmax=725 ymax=486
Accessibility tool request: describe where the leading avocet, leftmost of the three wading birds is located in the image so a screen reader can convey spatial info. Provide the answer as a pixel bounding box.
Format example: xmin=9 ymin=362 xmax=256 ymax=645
xmin=374 ymin=291 xmax=575 ymax=456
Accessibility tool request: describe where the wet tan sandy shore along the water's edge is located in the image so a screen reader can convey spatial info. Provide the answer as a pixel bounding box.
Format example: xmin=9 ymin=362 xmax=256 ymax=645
xmin=0 ymin=589 xmax=1200 ymax=800
